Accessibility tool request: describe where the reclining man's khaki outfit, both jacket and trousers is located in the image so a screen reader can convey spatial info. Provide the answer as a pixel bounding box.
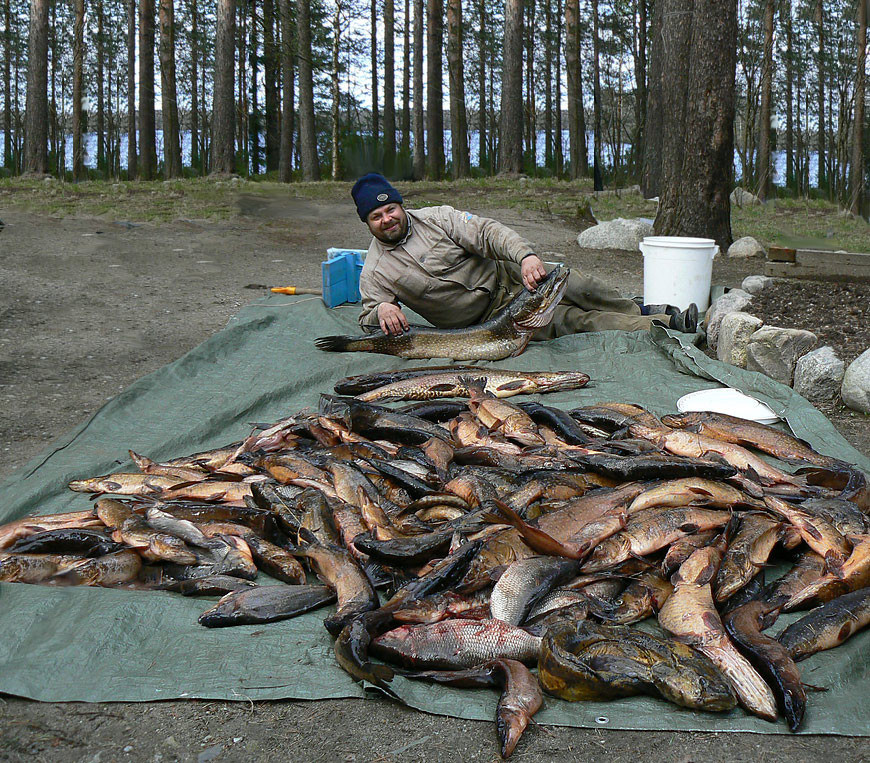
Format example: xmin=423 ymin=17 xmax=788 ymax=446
xmin=359 ymin=205 xmax=668 ymax=339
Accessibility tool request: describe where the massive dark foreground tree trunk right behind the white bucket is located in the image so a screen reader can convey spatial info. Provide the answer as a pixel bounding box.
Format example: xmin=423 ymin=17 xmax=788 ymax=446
xmin=654 ymin=0 xmax=737 ymax=249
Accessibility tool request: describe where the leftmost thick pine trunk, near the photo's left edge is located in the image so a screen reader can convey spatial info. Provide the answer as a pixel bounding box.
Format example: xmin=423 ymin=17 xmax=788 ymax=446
xmin=23 ymin=0 xmax=49 ymax=175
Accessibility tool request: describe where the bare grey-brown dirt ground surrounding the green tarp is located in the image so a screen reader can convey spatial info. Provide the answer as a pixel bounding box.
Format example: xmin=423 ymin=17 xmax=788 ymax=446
xmin=0 ymin=187 xmax=870 ymax=763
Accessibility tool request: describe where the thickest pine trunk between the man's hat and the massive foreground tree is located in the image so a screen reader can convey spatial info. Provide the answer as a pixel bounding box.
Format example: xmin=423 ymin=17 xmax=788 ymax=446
xmin=498 ymin=0 xmax=523 ymax=174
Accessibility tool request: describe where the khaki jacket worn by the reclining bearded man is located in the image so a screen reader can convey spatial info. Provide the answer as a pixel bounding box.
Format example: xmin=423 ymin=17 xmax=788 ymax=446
xmin=359 ymin=206 xmax=534 ymax=328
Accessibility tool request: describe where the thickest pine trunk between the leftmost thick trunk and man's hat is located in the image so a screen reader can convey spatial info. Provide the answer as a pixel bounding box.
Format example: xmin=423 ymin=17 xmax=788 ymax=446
xmin=211 ymin=0 xmax=236 ymax=175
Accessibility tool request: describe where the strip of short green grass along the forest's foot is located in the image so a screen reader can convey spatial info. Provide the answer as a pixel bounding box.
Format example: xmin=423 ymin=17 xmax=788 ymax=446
xmin=0 ymin=177 xmax=870 ymax=252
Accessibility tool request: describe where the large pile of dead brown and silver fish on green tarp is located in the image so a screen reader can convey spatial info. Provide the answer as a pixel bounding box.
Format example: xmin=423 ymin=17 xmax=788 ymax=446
xmin=0 ymin=366 xmax=870 ymax=756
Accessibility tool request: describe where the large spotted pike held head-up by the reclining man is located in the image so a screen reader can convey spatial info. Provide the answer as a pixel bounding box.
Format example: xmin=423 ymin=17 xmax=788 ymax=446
xmin=314 ymin=266 xmax=570 ymax=360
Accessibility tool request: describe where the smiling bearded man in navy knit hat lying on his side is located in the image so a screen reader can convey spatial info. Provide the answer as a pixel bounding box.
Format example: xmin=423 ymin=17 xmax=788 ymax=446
xmin=351 ymin=173 xmax=698 ymax=340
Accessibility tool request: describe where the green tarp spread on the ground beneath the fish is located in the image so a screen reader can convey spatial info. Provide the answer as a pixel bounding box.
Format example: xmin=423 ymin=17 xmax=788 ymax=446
xmin=0 ymin=297 xmax=870 ymax=735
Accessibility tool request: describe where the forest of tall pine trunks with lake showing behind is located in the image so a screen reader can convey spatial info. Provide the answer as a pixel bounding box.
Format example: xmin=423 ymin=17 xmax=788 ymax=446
xmin=0 ymin=0 xmax=870 ymax=237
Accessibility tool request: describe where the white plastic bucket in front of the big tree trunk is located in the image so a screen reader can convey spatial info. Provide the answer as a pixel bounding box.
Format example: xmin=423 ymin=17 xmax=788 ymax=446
xmin=640 ymin=236 xmax=719 ymax=314
